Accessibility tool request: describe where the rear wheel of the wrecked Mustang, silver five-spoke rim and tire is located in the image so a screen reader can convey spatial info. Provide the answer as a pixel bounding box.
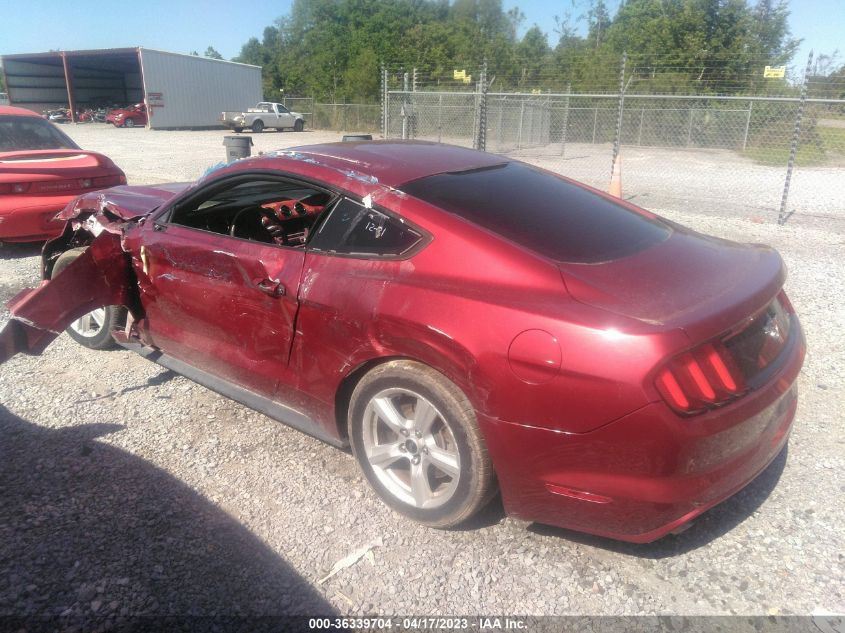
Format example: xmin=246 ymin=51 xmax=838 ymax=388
xmin=348 ymin=361 xmax=496 ymax=528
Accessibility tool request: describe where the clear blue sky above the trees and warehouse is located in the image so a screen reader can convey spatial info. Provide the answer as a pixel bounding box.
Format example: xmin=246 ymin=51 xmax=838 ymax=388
xmin=0 ymin=0 xmax=845 ymax=72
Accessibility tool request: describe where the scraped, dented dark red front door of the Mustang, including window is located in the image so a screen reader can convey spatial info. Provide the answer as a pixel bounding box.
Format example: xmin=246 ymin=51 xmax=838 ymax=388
xmin=133 ymin=176 xmax=324 ymax=396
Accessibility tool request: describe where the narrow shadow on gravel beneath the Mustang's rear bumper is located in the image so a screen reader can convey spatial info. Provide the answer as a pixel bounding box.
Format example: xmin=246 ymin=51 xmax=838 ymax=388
xmin=528 ymin=445 xmax=789 ymax=559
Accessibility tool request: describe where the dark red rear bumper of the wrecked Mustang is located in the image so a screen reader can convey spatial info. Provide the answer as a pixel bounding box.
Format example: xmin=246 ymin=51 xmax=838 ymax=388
xmin=479 ymin=319 xmax=805 ymax=543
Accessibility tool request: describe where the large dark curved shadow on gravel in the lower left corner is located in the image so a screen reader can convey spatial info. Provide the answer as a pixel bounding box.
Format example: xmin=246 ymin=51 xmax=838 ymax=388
xmin=0 ymin=405 xmax=334 ymax=630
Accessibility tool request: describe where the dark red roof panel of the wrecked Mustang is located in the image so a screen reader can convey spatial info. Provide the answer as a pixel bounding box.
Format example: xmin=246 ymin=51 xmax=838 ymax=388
xmin=287 ymin=140 xmax=511 ymax=187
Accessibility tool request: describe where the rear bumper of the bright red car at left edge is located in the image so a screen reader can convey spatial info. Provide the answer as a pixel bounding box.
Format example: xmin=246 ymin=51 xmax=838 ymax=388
xmin=0 ymin=193 xmax=73 ymax=242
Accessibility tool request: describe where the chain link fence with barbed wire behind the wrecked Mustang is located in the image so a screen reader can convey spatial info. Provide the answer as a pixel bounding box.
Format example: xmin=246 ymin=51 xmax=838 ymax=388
xmin=381 ymin=61 xmax=845 ymax=230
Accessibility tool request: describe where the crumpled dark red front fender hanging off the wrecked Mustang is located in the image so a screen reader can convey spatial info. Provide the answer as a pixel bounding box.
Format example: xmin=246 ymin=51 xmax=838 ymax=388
xmin=0 ymin=231 xmax=137 ymax=363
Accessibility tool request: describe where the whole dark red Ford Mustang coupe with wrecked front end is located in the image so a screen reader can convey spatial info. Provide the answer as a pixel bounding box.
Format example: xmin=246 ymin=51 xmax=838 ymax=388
xmin=0 ymin=142 xmax=805 ymax=542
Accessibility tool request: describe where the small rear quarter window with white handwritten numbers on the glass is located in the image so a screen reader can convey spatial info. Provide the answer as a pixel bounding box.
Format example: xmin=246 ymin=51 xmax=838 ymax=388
xmin=310 ymin=198 xmax=422 ymax=256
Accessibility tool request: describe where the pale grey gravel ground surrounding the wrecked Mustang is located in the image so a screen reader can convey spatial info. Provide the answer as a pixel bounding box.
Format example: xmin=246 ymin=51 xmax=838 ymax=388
xmin=0 ymin=126 xmax=845 ymax=618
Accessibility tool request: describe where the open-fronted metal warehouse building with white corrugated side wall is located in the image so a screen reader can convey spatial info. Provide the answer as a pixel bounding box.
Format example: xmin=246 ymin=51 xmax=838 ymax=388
xmin=2 ymin=48 xmax=263 ymax=129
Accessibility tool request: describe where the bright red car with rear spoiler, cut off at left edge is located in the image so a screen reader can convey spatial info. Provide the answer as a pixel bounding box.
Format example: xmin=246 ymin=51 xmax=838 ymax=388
xmin=0 ymin=106 xmax=126 ymax=242
